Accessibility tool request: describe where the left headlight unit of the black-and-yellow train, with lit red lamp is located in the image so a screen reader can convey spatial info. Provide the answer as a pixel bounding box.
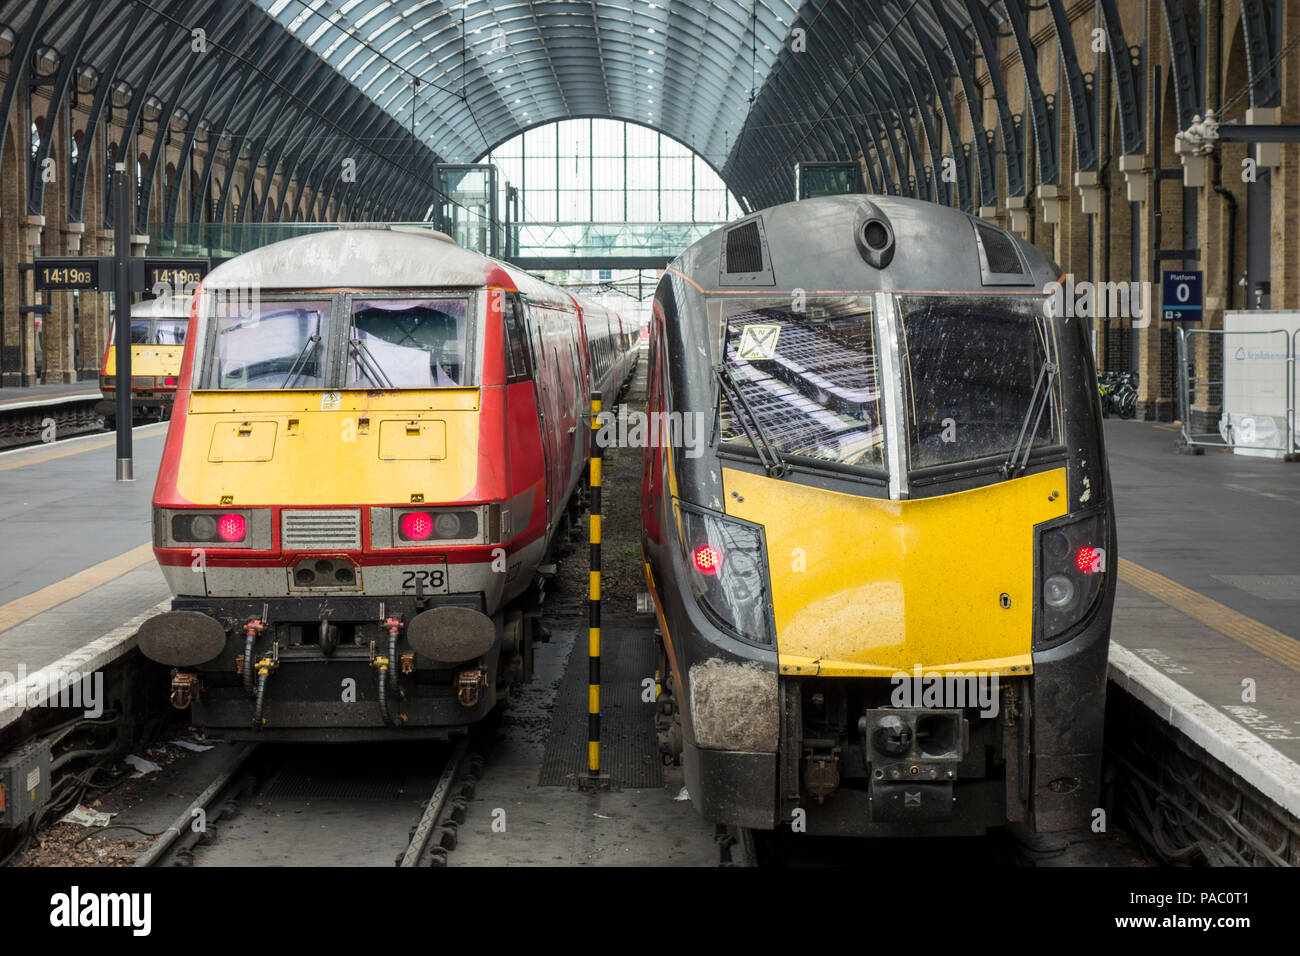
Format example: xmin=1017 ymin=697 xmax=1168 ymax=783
xmin=677 ymin=502 xmax=774 ymax=645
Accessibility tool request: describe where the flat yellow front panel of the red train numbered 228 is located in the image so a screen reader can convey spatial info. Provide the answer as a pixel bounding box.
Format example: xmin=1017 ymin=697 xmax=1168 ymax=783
xmin=177 ymin=389 xmax=478 ymax=505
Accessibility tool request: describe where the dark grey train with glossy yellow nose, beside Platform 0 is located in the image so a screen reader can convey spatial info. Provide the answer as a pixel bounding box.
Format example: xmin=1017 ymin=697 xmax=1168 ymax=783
xmin=642 ymin=195 xmax=1115 ymax=835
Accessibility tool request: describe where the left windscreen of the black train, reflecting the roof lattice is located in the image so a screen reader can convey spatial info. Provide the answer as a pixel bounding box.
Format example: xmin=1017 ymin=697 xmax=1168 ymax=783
xmin=712 ymin=297 xmax=884 ymax=472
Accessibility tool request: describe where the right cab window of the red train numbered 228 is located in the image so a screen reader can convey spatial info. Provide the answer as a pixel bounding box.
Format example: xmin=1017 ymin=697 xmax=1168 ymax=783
xmin=343 ymin=297 xmax=473 ymax=389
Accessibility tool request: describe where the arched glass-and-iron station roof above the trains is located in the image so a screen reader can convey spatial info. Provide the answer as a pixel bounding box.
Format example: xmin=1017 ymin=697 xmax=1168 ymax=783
xmin=0 ymin=0 xmax=1281 ymax=217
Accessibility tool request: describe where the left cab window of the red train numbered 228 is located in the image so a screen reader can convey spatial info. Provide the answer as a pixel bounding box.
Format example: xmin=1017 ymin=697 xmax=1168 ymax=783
xmin=203 ymin=297 xmax=333 ymax=389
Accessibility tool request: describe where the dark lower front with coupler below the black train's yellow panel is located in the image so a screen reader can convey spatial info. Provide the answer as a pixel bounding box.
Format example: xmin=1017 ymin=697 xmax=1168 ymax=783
xmin=653 ymin=538 xmax=1113 ymax=836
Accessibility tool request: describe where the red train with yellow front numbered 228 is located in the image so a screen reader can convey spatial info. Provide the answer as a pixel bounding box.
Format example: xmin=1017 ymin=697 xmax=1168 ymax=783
xmin=139 ymin=228 xmax=636 ymax=740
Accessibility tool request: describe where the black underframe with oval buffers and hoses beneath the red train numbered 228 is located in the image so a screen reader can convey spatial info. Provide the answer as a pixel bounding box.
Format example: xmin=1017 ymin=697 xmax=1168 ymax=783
xmin=140 ymin=486 xmax=585 ymax=743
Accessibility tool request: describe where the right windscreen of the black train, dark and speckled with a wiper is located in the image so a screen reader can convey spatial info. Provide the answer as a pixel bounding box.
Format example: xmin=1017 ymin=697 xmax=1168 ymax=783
xmin=898 ymin=295 xmax=1061 ymax=470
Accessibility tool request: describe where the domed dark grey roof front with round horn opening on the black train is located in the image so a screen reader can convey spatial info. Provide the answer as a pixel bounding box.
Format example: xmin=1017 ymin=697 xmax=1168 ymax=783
xmin=670 ymin=195 xmax=1060 ymax=294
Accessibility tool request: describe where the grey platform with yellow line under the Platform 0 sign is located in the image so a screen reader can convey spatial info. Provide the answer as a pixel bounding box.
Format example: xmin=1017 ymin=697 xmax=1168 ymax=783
xmin=1105 ymin=420 xmax=1300 ymax=817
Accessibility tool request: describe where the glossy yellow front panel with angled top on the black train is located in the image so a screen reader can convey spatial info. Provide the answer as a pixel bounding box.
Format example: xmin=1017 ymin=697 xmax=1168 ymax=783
xmin=723 ymin=468 xmax=1066 ymax=676
